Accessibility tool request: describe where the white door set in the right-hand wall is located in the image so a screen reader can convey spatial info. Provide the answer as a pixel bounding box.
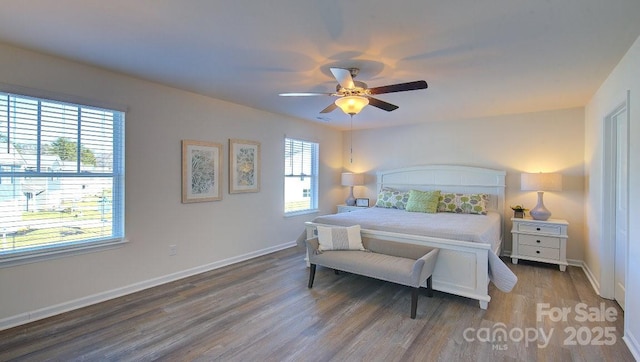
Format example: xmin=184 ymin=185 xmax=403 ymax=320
xmin=612 ymin=109 xmax=629 ymax=310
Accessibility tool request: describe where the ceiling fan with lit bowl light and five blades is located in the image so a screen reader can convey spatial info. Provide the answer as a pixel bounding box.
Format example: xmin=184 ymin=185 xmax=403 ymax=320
xmin=280 ymin=68 xmax=427 ymax=116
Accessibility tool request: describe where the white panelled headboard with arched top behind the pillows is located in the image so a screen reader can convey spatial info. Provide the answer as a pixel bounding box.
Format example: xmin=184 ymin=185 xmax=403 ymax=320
xmin=377 ymin=165 xmax=507 ymax=215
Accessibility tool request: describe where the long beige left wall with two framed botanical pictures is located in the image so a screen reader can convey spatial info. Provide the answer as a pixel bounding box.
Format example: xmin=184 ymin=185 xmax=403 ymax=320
xmin=0 ymin=45 xmax=342 ymax=329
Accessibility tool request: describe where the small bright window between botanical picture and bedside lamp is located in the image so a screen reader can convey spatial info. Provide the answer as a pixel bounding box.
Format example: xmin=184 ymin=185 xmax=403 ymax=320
xmin=284 ymin=138 xmax=318 ymax=215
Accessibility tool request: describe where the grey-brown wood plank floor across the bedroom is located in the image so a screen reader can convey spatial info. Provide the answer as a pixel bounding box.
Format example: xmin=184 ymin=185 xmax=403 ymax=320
xmin=0 ymin=248 xmax=633 ymax=361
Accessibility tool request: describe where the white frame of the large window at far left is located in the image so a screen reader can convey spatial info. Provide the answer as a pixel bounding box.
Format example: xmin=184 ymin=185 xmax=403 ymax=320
xmin=0 ymin=90 xmax=127 ymax=268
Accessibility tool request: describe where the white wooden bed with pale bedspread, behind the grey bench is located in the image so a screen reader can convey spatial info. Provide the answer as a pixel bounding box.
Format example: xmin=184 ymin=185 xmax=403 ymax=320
xmin=306 ymin=165 xmax=517 ymax=309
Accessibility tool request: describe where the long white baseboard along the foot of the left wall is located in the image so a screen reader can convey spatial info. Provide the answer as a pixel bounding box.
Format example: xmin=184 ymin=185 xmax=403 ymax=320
xmin=0 ymin=241 xmax=297 ymax=331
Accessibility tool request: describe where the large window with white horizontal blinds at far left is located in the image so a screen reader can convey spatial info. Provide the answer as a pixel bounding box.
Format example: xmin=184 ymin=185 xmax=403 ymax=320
xmin=0 ymin=92 xmax=124 ymax=262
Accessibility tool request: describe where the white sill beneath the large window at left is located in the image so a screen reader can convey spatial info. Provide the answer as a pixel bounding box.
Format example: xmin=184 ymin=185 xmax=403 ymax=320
xmin=0 ymin=239 xmax=129 ymax=268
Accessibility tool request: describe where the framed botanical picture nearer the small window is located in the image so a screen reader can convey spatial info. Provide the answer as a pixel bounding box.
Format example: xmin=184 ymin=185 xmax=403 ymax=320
xmin=229 ymin=139 xmax=260 ymax=194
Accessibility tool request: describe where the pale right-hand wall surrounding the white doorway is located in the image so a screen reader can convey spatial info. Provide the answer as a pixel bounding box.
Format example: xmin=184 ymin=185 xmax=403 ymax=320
xmin=585 ymin=34 xmax=640 ymax=359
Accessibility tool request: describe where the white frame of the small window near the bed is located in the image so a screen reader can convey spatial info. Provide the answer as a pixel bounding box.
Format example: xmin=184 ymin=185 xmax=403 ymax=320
xmin=282 ymin=136 xmax=320 ymax=217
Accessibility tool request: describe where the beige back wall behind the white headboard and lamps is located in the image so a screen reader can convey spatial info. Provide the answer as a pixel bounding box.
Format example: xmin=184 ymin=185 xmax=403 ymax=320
xmin=343 ymin=108 xmax=584 ymax=261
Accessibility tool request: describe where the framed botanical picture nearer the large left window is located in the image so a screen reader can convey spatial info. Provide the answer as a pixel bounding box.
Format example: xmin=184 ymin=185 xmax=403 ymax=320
xmin=182 ymin=140 xmax=222 ymax=203
